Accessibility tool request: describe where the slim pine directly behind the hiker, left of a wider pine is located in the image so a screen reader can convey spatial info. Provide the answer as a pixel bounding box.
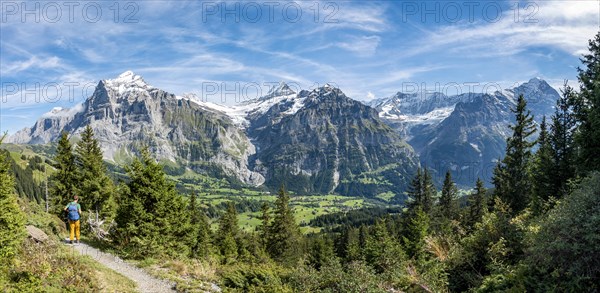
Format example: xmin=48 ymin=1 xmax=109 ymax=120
xmin=49 ymin=131 xmax=77 ymax=214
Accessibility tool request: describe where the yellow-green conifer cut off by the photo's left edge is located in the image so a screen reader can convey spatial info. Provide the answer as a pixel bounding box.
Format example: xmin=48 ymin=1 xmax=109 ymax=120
xmin=0 ymin=136 xmax=25 ymax=268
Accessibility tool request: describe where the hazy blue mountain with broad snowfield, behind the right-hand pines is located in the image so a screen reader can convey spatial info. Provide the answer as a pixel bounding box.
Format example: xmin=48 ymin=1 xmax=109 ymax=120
xmin=375 ymin=78 xmax=559 ymax=188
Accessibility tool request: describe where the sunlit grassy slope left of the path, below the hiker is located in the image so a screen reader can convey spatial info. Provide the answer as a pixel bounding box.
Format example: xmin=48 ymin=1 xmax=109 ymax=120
xmin=0 ymin=199 xmax=136 ymax=292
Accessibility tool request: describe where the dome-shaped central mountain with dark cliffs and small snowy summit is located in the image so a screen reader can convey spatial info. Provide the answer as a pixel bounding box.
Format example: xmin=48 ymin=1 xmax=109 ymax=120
xmin=248 ymin=86 xmax=418 ymax=196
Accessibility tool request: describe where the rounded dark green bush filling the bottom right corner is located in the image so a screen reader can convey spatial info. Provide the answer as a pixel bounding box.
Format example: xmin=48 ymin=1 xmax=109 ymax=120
xmin=526 ymin=172 xmax=600 ymax=292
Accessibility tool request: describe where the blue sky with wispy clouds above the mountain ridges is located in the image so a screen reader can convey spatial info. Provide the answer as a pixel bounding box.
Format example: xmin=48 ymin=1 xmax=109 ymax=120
xmin=0 ymin=1 xmax=600 ymax=133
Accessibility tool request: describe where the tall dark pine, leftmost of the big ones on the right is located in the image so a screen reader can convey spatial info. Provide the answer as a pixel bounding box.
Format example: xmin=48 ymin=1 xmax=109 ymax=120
xmin=493 ymin=95 xmax=535 ymax=213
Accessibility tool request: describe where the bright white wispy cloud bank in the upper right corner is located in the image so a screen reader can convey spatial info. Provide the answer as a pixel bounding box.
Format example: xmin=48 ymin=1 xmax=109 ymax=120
xmin=411 ymin=1 xmax=600 ymax=57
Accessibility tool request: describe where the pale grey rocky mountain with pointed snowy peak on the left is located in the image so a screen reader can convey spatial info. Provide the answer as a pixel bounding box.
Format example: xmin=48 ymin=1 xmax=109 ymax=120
xmin=9 ymin=71 xmax=264 ymax=185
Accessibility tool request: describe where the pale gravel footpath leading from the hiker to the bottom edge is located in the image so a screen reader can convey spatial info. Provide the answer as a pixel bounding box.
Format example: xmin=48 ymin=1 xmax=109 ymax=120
xmin=68 ymin=243 xmax=176 ymax=293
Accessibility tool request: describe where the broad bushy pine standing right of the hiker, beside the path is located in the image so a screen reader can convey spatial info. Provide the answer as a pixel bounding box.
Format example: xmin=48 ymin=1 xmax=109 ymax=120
xmin=113 ymin=149 xmax=191 ymax=257
